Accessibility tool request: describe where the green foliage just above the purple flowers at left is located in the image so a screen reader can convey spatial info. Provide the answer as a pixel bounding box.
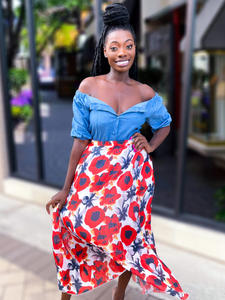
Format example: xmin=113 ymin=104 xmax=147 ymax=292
xmin=9 ymin=68 xmax=28 ymax=94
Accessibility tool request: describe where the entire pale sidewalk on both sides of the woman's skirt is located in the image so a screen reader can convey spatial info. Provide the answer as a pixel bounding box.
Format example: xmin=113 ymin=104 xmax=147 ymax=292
xmin=0 ymin=194 xmax=225 ymax=300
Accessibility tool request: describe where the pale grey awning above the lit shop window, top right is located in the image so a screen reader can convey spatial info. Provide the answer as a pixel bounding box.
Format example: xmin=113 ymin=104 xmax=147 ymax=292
xmin=180 ymin=0 xmax=225 ymax=51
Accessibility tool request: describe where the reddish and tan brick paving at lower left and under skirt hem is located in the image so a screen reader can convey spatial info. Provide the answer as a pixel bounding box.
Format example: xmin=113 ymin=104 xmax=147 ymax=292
xmin=0 ymin=233 xmax=162 ymax=300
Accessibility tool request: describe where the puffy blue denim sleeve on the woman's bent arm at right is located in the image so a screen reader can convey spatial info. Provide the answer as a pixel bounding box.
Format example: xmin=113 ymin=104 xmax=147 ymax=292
xmin=146 ymin=94 xmax=172 ymax=133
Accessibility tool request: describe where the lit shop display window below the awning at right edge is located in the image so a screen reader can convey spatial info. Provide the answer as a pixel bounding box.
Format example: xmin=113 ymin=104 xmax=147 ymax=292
xmin=189 ymin=51 xmax=225 ymax=145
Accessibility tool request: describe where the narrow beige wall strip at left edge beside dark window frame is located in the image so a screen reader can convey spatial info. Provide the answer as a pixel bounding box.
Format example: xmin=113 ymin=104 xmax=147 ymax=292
xmin=0 ymin=61 xmax=9 ymax=192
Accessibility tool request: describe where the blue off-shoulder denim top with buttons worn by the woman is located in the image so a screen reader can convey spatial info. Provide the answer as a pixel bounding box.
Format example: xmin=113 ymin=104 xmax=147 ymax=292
xmin=71 ymin=90 xmax=172 ymax=141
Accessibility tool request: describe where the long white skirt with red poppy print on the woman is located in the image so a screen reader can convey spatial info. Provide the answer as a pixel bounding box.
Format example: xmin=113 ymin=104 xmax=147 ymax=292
xmin=53 ymin=140 xmax=189 ymax=299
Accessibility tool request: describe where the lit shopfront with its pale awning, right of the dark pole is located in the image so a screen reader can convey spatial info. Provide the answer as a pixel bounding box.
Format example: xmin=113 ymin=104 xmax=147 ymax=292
xmin=181 ymin=1 xmax=225 ymax=166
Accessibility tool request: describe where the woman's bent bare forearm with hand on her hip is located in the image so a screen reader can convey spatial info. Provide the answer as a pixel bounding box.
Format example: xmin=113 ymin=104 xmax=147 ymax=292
xmin=133 ymin=125 xmax=170 ymax=153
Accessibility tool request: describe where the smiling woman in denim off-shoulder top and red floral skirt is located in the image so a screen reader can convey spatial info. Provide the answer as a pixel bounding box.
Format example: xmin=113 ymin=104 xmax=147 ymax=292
xmin=46 ymin=3 xmax=188 ymax=300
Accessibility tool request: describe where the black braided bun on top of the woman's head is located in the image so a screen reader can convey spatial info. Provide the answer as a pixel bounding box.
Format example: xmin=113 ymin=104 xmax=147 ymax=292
xmin=102 ymin=3 xmax=130 ymax=25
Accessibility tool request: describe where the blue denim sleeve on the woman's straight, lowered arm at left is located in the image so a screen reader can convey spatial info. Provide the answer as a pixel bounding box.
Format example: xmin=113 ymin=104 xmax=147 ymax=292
xmin=70 ymin=91 xmax=92 ymax=140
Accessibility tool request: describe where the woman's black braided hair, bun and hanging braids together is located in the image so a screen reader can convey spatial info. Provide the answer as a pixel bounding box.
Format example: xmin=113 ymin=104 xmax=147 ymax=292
xmin=91 ymin=3 xmax=138 ymax=80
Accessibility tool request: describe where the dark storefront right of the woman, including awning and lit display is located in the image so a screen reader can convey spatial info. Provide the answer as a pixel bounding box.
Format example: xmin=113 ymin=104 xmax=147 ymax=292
xmin=143 ymin=0 xmax=225 ymax=226
